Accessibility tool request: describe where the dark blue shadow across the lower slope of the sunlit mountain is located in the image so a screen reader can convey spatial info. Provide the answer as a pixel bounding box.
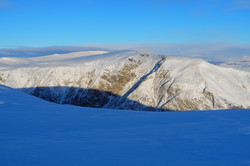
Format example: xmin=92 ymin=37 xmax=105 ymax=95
xmin=19 ymin=86 xmax=169 ymax=111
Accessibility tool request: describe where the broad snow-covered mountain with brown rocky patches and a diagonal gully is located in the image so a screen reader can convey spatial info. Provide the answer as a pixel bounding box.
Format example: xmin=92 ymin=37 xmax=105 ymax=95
xmin=0 ymin=50 xmax=250 ymax=110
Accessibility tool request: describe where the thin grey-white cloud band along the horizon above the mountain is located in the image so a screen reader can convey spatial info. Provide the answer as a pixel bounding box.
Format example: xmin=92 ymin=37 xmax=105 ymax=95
xmin=0 ymin=43 xmax=250 ymax=61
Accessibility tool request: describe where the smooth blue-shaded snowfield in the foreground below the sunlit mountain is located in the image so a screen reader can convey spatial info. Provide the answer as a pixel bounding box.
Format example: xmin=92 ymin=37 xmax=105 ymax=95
xmin=0 ymin=86 xmax=250 ymax=166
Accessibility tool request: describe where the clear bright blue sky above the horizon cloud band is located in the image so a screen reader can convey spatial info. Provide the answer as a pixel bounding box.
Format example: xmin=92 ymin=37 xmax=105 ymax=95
xmin=0 ymin=0 xmax=250 ymax=48
